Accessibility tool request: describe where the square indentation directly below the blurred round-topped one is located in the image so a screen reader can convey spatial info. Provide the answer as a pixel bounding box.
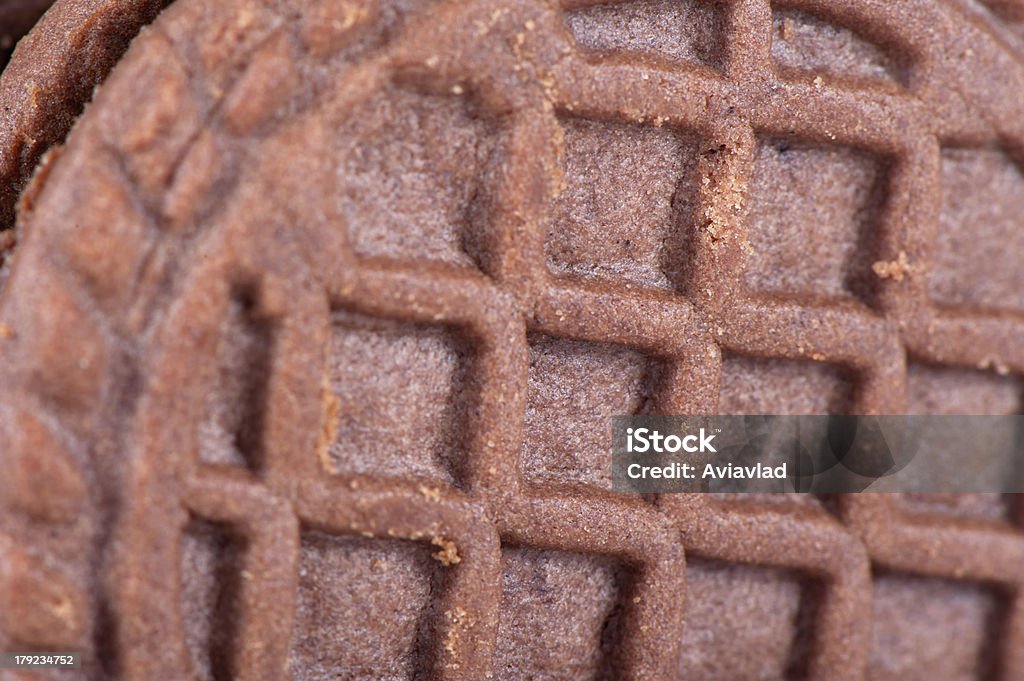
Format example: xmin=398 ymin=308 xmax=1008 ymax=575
xmin=325 ymin=311 xmax=469 ymax=482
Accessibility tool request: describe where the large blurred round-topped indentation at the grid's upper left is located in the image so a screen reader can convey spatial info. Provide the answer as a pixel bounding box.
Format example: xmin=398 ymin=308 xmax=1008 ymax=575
xmin=336 ymin=82 xmax=495 ymax=266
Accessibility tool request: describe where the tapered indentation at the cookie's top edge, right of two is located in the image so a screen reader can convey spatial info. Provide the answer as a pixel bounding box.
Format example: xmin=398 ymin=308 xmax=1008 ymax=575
xmin=771 ymin=8 xmax=903 ymax=83
